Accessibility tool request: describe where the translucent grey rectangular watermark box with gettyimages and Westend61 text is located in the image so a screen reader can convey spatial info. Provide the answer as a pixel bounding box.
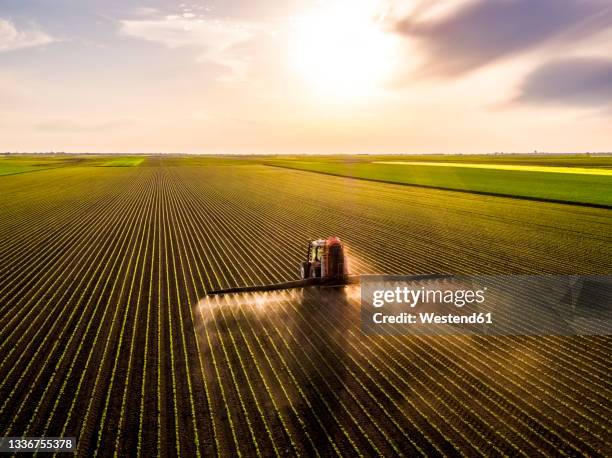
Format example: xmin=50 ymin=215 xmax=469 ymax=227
xmin=361 ymin=275 xmax=612 ymax=336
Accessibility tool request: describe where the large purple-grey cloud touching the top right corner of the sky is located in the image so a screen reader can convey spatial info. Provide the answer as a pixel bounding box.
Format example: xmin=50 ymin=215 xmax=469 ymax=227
xmin=396 ymin=0 xmax=612 ymax=76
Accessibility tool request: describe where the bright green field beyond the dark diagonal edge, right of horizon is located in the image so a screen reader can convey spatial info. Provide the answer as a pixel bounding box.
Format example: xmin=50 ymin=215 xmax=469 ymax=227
xmin=267 ymin=156 xmax=612 ymax=207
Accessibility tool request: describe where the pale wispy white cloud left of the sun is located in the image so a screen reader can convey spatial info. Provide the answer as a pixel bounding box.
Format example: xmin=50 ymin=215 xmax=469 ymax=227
xmin=120 ymin=15 xmax=262 ymax=75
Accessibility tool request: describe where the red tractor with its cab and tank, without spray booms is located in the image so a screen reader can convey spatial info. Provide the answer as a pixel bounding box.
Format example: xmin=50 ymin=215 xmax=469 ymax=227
xmin=300 ymin=237 xmax=348 ymax=282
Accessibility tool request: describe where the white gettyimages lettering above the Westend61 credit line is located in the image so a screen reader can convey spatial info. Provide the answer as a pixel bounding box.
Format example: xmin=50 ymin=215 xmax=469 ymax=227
xmin=372 ymin=286 xmax=487 ymax=308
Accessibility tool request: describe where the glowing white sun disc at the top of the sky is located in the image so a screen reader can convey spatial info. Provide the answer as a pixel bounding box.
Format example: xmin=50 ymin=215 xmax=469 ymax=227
xmin=291 ymin=0 xmax=395 ymax=97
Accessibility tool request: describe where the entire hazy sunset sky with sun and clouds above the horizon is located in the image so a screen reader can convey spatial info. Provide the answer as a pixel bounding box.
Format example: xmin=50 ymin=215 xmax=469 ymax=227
xmin=0 ymin=0 xmax=612 ymax=154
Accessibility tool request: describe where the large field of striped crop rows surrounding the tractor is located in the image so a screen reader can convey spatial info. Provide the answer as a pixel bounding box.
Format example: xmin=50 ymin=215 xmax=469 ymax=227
xmin=0 ymin=156 xmax=612 ymax=457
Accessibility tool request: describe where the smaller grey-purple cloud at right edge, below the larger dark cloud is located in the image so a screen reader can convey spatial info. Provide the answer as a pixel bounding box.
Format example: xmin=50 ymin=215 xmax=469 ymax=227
xmin=515 ymin=58 xmax=612 ymax=108
